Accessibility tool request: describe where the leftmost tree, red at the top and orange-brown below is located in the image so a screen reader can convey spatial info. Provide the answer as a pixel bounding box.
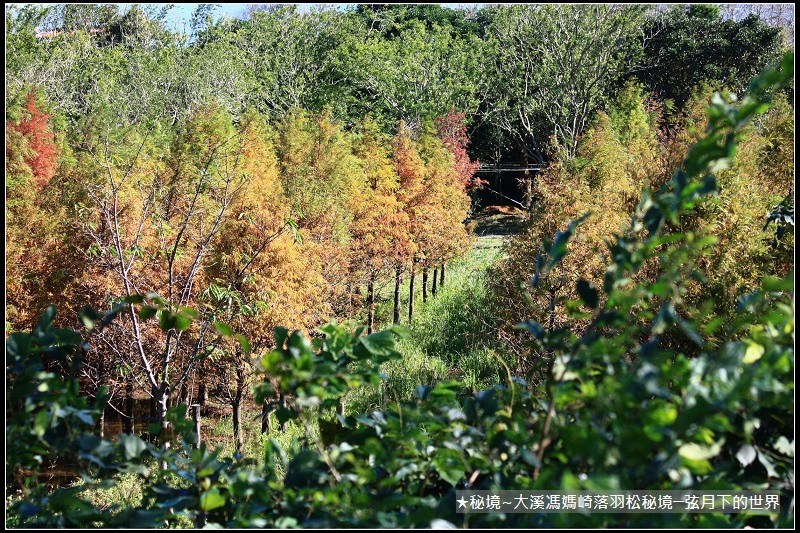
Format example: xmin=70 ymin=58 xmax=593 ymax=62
xmin=5 ymin=89 xmax=80 ymax=331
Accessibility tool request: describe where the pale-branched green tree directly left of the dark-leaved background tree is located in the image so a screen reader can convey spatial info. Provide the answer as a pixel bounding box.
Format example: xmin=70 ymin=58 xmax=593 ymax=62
xmin=486 ymin=5 xmax=643 ymax=162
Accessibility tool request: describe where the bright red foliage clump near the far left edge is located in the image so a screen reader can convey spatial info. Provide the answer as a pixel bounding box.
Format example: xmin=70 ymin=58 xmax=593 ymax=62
xmin=6 ymin=89 xmax=59 ymax=189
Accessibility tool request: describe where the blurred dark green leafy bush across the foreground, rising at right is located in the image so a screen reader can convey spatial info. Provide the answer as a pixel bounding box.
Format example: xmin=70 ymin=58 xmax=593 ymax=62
xmin=6 ymin=56 xmax=794 ymax=527
